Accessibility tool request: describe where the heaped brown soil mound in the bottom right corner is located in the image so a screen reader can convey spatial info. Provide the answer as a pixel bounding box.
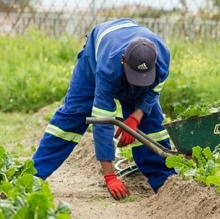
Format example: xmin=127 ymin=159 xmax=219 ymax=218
xmin=132 ymin=176 xmax=220 ymax=219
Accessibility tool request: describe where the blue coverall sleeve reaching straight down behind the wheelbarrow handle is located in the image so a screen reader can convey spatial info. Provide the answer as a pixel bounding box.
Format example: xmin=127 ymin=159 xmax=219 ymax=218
xmin=92 ymin=72 xmax=116 ymax=161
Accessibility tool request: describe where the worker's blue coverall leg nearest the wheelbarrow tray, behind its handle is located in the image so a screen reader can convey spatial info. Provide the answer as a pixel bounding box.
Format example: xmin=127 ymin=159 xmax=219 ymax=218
xmin=118 ymin=102 xmax=175 ymax=192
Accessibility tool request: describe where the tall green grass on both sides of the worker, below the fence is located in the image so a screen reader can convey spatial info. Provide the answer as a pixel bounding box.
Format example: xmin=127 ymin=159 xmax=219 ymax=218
xmin=0 ymin=29 xmax=220 ymax=118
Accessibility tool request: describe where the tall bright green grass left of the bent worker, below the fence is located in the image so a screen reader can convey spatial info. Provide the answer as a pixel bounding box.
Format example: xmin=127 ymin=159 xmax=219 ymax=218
xmin=0 ymin=29 xmax=80 ymax=112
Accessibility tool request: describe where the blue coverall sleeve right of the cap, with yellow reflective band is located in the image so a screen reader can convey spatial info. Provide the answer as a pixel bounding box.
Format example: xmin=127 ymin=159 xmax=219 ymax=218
xmin=136 ymin=45 xmax=170 ymax=115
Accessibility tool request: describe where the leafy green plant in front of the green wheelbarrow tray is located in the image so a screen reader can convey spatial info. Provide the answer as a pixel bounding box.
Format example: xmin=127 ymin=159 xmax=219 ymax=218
xmin=166 ymin=145 xmax=220 ymax=193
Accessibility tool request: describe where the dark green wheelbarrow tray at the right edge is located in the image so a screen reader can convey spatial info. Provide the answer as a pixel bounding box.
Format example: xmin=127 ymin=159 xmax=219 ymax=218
xmin=164 ymin=112 xmax=220 ymax=155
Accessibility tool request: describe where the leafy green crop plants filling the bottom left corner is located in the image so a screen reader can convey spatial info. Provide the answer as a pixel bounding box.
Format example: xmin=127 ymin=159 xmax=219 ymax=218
xmin=0 ymin=147 xmax=71 ymax=219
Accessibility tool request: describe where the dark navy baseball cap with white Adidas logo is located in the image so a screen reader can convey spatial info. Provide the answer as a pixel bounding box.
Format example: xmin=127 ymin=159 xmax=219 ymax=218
xmin=124 ymin=38 xmax=157 ymax=86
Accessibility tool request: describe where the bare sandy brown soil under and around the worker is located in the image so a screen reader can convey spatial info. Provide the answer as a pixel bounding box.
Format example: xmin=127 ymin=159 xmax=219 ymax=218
xmin=32 ymin=108 xmax=220 ymax=219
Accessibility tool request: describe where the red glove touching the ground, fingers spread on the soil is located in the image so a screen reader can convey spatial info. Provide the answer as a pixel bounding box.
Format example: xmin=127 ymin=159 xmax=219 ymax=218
xmin=104 ymin=173 xmax=129 ymax=200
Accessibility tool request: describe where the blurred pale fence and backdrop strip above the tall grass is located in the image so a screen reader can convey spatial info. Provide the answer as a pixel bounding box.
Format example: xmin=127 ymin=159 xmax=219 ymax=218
xmin=0 ymin=0 xmax=220 ymax=40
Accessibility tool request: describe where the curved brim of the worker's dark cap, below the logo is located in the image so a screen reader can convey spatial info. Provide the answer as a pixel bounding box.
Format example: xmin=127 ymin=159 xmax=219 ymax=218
xmin=124 ymin=64 xmax=156 ymax=87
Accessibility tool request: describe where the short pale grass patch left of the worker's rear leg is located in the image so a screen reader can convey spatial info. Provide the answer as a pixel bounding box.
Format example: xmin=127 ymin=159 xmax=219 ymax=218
xmin=0 ymin=102 xmax=59 ymax=157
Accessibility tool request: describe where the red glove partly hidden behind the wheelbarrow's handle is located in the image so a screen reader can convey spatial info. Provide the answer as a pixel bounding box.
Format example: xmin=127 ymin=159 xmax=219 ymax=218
xmin=115 ymin=115 xmax=140 ymax=147
